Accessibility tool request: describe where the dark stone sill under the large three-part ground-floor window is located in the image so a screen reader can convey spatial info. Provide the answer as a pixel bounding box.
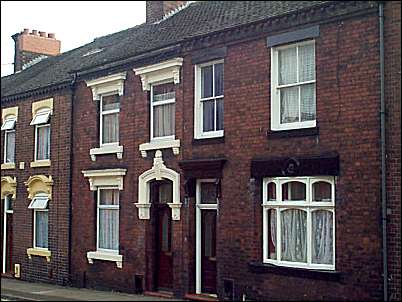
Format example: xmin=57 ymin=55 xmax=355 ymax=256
xmin=248 ymin=261 xmax=342 ymax=281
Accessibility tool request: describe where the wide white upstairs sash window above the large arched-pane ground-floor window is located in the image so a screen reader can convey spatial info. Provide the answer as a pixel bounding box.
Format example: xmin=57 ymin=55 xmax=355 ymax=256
xmin=271 ymin=41 xmax=316 ymax=130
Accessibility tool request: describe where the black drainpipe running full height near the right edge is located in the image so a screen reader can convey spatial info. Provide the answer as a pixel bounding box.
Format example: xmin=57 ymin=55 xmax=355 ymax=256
xmin=378 ymin=1 xmax=388 ymax=301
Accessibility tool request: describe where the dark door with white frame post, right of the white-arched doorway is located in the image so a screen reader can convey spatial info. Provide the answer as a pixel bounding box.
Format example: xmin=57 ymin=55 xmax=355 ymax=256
xmin=201 ymin=210 xmax=216 ymax=294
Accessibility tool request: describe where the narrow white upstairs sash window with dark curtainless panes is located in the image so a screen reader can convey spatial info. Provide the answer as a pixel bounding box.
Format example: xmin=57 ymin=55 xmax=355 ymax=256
xmin=195 ymin=61 xmax=224 ymax=138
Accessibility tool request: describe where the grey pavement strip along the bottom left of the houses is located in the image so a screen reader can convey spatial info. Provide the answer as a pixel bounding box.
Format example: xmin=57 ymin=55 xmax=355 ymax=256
xmin=1 ymin=278 xmax=179 ymax=301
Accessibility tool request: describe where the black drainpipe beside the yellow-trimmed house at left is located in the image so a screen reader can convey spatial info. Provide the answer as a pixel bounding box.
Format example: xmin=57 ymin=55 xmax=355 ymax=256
xmin=68 ymin=73 xmax=77 ymax=284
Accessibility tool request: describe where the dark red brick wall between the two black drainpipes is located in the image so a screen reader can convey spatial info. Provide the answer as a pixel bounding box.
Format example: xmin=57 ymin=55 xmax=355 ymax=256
xmin=72 ymin=9 xmax=390 ymax=300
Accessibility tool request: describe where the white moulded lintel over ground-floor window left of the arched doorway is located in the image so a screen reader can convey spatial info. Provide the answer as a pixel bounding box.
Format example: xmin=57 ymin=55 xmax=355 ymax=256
xmin=82 ymin=169 xmax=127 ymax=191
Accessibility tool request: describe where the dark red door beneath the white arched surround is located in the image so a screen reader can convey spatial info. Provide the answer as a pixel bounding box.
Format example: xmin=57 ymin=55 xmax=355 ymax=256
xmin=156 ymin=204 xmax=173 ymax=290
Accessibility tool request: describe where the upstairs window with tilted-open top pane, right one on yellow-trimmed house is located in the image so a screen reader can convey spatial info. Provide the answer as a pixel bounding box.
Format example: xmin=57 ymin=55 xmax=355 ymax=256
xmin=30 ymin=108 xmax=50 ymax=161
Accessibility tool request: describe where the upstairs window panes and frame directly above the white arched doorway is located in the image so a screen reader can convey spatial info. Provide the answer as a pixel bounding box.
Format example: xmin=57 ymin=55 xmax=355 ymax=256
xmin=151 ymin=82 xmax=176 ymax=140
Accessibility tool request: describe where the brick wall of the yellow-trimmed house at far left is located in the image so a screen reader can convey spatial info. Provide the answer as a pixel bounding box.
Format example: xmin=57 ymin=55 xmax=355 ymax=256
xmin=1 ymin=90 xmax=71 ymax=284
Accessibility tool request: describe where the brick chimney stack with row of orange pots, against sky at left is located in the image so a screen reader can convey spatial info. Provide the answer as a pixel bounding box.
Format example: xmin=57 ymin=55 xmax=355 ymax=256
xmin=11 ymin=28 xmax=61 ymax=72
